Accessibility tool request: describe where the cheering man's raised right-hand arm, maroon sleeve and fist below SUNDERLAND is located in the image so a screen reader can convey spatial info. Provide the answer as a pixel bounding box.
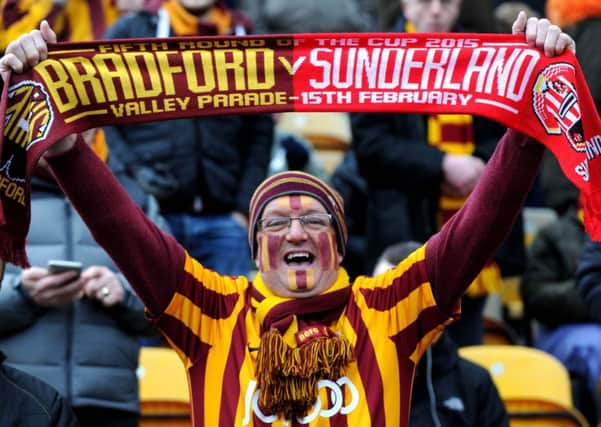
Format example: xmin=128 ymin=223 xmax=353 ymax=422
xmin=426 ymin=12 xmax=575 ymax=312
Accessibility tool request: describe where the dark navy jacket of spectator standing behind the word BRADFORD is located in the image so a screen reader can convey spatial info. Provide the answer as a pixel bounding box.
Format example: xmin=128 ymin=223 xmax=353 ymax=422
xmin=104 ymin=12 xmax=273 ymax=213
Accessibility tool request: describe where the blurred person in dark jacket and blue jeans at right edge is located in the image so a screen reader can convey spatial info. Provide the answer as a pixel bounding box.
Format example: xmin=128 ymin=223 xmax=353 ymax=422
xmin=520 ymin=202 xmax=601 ymax=425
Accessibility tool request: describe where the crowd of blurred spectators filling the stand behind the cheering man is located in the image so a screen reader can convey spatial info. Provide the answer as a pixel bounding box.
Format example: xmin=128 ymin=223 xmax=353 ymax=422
xmin=0 ymin=0 xmax=601 ymax=426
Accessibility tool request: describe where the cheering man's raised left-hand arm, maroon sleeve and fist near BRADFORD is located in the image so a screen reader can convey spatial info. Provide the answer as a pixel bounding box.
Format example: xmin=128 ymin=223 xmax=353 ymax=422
xmin=0 ymin=21 xmax=185 ymax=314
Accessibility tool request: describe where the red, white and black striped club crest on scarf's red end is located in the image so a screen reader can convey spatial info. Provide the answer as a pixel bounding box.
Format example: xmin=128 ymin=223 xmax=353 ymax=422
xmin=532 ymin=63 xmax=585 ymax=152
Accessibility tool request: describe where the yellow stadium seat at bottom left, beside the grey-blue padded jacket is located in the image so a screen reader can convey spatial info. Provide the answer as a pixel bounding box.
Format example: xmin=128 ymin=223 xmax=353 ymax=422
xmin=138 ymin=347 xmax=192 ymax=427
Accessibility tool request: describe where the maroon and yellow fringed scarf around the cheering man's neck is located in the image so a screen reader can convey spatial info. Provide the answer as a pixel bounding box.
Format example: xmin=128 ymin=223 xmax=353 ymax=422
xmin=251 ymin=268 xmax=354 ymax=420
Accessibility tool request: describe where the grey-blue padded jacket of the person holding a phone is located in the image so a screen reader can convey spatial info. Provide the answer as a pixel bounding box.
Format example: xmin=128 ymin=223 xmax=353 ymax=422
xmin=0 ymin=157 xmax=163 ymax=414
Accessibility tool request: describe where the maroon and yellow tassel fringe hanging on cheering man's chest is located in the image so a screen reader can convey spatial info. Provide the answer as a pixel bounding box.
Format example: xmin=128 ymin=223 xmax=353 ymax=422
xmin=257 ymin=328 xmax=355 ymax=420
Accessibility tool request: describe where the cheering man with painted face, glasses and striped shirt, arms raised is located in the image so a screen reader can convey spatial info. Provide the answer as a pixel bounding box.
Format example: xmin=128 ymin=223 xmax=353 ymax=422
xmin=0 ymin=14 xmax=574 ymax=427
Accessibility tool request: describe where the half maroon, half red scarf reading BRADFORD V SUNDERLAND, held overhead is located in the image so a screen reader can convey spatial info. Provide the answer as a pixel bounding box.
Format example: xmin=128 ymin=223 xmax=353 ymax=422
xmin=0 ymin=33 xmax=601 ymax=266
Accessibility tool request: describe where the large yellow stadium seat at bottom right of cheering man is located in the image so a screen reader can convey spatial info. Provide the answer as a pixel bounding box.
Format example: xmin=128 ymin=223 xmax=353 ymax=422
xmin=459 ymin=345 xmax=588 ymax=427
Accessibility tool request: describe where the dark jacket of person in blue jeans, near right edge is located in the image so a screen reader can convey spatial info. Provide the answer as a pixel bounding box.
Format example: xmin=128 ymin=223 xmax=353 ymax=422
xmin=520 ymin=208 xmax=591 ymax=328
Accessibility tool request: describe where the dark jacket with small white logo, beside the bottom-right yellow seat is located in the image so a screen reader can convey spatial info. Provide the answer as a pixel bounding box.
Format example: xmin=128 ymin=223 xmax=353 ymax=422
xmin=409 ymin=333 xmax=509 ymax=427
